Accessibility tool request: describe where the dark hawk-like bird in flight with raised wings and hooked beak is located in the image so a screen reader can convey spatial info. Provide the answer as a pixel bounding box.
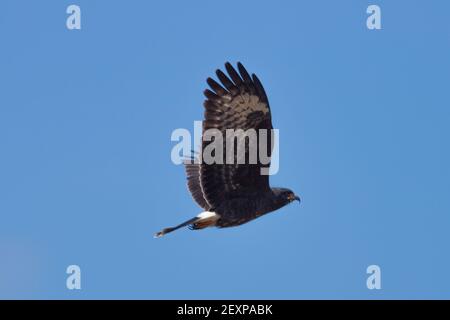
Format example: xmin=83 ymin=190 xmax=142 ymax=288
xmin=154 ymin=62 xmax=300 ymax=238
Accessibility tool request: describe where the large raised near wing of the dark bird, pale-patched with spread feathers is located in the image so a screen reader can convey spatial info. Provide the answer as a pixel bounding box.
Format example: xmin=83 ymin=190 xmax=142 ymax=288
xmin=194 ymin=62 xmax=273 ymax=208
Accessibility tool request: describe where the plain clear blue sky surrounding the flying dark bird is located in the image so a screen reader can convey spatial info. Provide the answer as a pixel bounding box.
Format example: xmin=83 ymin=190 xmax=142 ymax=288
xmin=0 ymin=0 xmax=450 ymax=299
